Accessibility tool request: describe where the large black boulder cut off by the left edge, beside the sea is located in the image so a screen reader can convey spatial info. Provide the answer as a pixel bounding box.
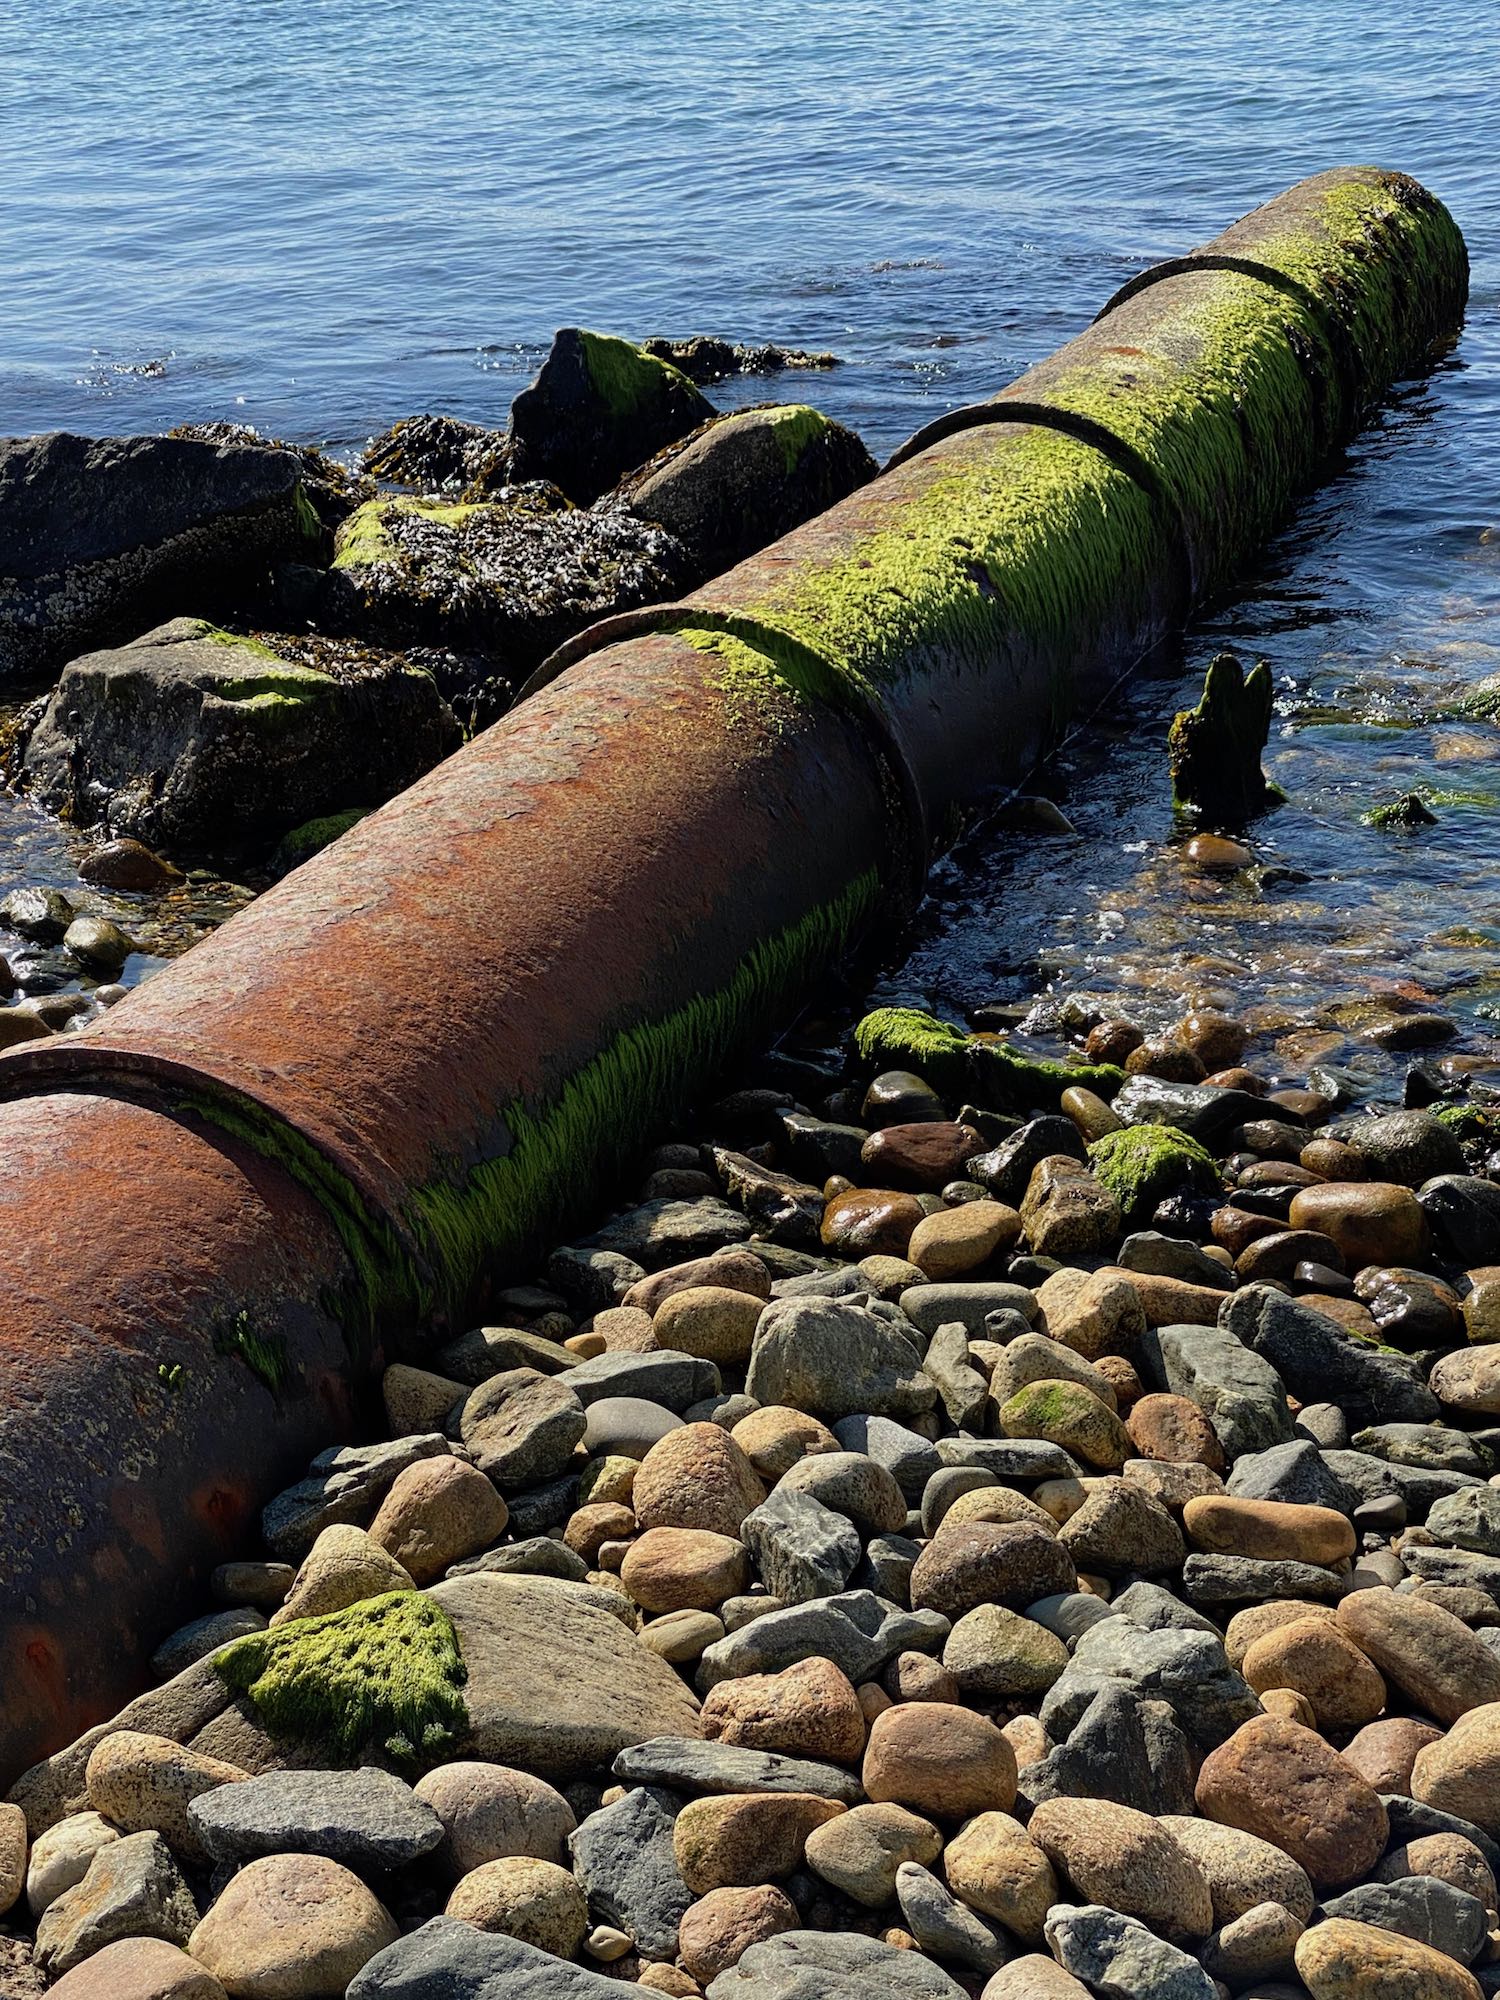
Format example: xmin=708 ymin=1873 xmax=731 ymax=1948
xmin=0 ymin=432 xmax=324 ymax=682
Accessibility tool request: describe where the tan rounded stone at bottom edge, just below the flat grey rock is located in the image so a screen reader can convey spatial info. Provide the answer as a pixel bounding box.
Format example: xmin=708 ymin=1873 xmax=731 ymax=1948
xmin=188 ymin=1854 xmax=400 ymax=2000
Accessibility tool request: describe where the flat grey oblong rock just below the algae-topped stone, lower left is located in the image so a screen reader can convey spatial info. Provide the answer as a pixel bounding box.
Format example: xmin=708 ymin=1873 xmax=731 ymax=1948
xmin=188 ymin=1770 xmax=442 ymax=1870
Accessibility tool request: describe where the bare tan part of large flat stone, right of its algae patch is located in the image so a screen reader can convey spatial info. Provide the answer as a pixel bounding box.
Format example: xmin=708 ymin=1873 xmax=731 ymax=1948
xmin=430 ymin=1572 xmax=702 ymax=1778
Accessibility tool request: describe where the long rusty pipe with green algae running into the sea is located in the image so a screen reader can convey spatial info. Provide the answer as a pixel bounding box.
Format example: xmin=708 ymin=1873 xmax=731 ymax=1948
xmin=0 ymin=168 xmax=1466 ymax=1772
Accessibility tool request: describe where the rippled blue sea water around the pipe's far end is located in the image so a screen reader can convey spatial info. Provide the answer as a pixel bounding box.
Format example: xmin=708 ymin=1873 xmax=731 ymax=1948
xmin=0 ymin=0 xmax=1500 ymax=1056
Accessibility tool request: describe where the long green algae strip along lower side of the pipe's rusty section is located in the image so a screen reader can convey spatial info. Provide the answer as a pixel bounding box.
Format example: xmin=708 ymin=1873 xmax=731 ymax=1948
xmin=406 ymin=868 xmax=882 ymax=1300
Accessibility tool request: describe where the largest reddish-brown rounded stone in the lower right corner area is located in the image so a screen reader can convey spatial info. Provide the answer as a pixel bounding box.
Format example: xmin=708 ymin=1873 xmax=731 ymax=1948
xmin=1196 ymin=1716 xmax=1390 ymax=1892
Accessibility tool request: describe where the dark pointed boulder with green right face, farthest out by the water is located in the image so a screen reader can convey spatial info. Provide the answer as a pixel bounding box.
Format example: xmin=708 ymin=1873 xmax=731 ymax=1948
xmin=510 ymin=326 xmax=714 ymax=506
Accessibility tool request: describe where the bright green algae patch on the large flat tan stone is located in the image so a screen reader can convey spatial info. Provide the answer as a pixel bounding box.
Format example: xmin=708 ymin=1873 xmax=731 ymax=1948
xmin=214 ymin=1590 xmax=468 ymax=1764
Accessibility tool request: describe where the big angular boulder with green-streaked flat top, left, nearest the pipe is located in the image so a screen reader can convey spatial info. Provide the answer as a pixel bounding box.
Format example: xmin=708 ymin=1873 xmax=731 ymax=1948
xmin=26 ymin=618 xmax=460 ymax=852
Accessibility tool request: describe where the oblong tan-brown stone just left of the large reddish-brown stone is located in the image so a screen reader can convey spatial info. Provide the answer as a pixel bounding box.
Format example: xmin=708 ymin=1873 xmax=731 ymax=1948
xmin=1026 ymin=1798 xmax=1214 ymax=1938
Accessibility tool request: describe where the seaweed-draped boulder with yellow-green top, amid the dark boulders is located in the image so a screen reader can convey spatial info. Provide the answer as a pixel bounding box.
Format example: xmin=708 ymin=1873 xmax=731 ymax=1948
xmin=324 ymin=482 xmax=692 ymax=682
